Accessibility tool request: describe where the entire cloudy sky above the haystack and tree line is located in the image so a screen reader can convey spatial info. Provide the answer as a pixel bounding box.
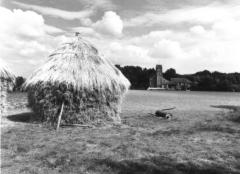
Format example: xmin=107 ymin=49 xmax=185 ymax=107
xmin=0 ymin=0 xmax=240 ymax=77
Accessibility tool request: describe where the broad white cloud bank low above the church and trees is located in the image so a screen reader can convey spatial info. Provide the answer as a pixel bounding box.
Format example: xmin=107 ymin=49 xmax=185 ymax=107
xmin=84 ymin=14 xmax=240 ymax=73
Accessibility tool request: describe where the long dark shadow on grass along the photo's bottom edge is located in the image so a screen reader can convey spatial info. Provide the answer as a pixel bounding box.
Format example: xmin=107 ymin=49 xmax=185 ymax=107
xmin=88 ymin=156 xmax=237 ymax=174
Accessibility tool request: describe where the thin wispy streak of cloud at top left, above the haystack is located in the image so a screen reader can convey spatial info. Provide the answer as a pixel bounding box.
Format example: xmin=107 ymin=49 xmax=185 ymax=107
xmin=12 ymin=1 xmax=94 ymax=24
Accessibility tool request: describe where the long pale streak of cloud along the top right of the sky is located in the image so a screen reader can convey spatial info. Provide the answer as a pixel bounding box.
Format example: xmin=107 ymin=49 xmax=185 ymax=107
xmin=124 ymin=3 xmax=240 ymax=27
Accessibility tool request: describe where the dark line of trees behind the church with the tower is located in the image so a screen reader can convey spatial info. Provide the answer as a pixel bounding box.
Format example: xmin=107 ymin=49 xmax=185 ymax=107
xmin=116 ymin=65 xmax=240 ymax=92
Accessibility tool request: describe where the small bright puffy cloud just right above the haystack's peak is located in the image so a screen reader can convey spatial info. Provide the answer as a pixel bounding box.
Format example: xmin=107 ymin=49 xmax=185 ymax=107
xmin=92 ymin=11 xmax=123 ymax=36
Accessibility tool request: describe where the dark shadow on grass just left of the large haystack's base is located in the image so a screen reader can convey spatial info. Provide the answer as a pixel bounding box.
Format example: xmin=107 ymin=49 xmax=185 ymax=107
xmin=7 ymin=112 xmax=40 ymax=123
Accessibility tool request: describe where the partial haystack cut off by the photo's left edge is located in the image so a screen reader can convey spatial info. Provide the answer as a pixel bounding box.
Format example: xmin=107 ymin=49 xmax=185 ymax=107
xmin=0 ymin=59 xmax=15 ymax=115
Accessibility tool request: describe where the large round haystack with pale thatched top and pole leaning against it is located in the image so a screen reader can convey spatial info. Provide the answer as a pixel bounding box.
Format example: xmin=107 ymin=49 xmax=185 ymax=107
xmin=25 ymin=36 xmax=130 ymax=125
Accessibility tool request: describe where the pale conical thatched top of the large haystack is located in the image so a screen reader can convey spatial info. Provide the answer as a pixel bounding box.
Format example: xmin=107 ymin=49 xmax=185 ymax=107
xmin=27 ymin=36 xmax=129 ymax=92
